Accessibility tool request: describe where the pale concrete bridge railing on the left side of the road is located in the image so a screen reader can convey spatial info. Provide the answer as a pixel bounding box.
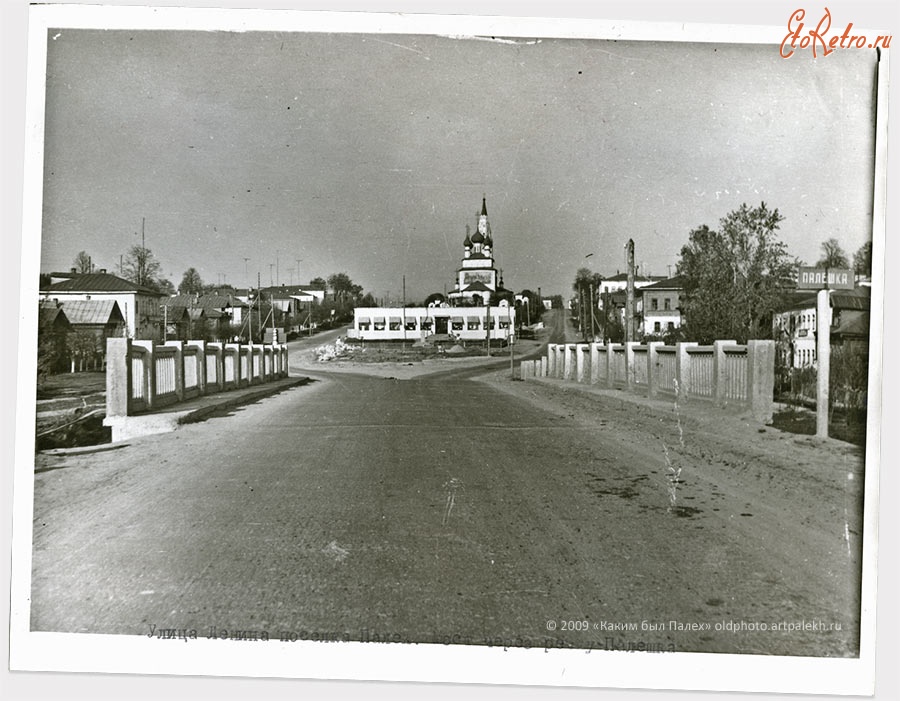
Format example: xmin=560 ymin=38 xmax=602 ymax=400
xmin=106 ymin=338 xmax=288 ymax=417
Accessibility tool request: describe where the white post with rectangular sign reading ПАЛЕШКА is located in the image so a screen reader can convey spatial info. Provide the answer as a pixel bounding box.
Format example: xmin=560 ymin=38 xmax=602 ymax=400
xmin=797 ymin=266 xmax=854 ymax=438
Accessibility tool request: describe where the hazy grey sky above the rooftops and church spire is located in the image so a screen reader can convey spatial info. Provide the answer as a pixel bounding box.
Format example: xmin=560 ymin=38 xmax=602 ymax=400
xmin=41 ymin=18 xmax=876 ymax=302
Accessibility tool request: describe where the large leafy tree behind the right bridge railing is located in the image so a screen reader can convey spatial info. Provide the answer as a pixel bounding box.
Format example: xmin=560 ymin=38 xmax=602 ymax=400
xmin=677 ymin=202 xmax=796 ymax=343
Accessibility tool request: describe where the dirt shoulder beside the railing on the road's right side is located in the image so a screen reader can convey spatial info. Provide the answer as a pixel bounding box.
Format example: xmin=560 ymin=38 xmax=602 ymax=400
xmin=476 ymin=372 xmax=865 ymax=655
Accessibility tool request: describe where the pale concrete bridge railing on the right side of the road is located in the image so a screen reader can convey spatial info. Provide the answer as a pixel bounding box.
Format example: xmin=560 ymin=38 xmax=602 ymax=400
xmin=520 ymin=340 xmax=775 ymax=423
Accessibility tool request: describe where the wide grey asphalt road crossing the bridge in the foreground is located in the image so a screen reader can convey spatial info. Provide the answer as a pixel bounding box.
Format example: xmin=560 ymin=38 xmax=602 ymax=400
xmin=31 ymin=328 xmax=858 ymax=656
